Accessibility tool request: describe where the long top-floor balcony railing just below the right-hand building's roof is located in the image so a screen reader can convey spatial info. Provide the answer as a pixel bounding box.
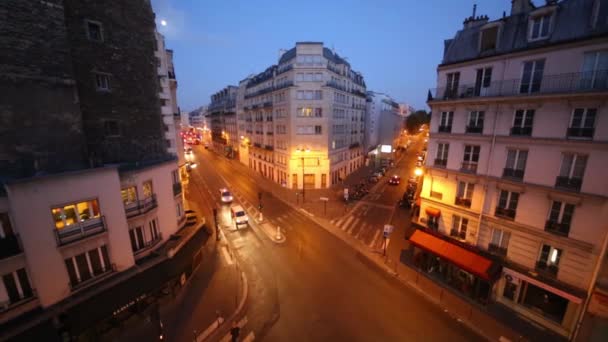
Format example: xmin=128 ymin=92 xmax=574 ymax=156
xmin=428 ymin=70 xmax=608 ymax=101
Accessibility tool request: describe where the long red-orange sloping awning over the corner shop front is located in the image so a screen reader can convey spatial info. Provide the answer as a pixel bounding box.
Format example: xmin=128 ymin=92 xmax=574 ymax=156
xmin=410 ymin=230 xmax=492 ymax=281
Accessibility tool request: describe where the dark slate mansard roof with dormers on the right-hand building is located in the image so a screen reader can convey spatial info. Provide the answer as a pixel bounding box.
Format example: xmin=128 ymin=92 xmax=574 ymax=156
xmin=441 ymin=0 xmax=608 ymax=65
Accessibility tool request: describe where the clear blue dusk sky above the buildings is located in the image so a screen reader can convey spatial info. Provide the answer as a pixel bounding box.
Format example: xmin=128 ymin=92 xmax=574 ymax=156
xmin=152 ymin=0 xmax=512 ymax=112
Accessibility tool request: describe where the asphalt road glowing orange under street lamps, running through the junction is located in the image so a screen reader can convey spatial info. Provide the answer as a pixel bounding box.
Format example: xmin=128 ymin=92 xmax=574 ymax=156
xmin=189 ymin=138 xmax=482 ymax=341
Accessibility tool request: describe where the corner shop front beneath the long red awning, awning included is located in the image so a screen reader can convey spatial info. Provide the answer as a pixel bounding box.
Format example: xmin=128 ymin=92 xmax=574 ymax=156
xmin=409 ymin=230 xmax=500 ymax=305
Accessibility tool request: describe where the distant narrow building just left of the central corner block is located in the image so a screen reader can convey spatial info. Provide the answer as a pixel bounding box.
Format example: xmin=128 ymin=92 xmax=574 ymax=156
xmin=206 ymin=85 xmax=239 ymax=158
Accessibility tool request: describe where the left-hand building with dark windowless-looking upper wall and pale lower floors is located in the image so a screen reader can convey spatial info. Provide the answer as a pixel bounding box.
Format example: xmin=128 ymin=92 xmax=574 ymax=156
xmin=0 ymin=0 xmax=190 ymax=340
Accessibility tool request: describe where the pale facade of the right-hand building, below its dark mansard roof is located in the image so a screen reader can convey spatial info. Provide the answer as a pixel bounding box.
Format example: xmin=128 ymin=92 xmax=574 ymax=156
xmin=419 ymin=0 xmax=608 ymax=337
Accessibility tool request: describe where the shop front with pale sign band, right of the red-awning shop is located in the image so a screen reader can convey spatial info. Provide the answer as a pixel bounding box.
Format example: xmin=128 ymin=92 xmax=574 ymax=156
xmin=496 ymin=267 xmax=585 ymax=337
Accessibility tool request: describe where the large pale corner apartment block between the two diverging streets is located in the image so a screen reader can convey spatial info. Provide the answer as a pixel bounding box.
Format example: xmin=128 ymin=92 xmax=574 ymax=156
xmin=237 ymin=42 xmax=366 ymax=189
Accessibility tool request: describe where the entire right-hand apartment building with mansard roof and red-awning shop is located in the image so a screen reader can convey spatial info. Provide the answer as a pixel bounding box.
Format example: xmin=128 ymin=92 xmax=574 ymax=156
xmin=410 ymin=0 xmax=608 ymax=338
